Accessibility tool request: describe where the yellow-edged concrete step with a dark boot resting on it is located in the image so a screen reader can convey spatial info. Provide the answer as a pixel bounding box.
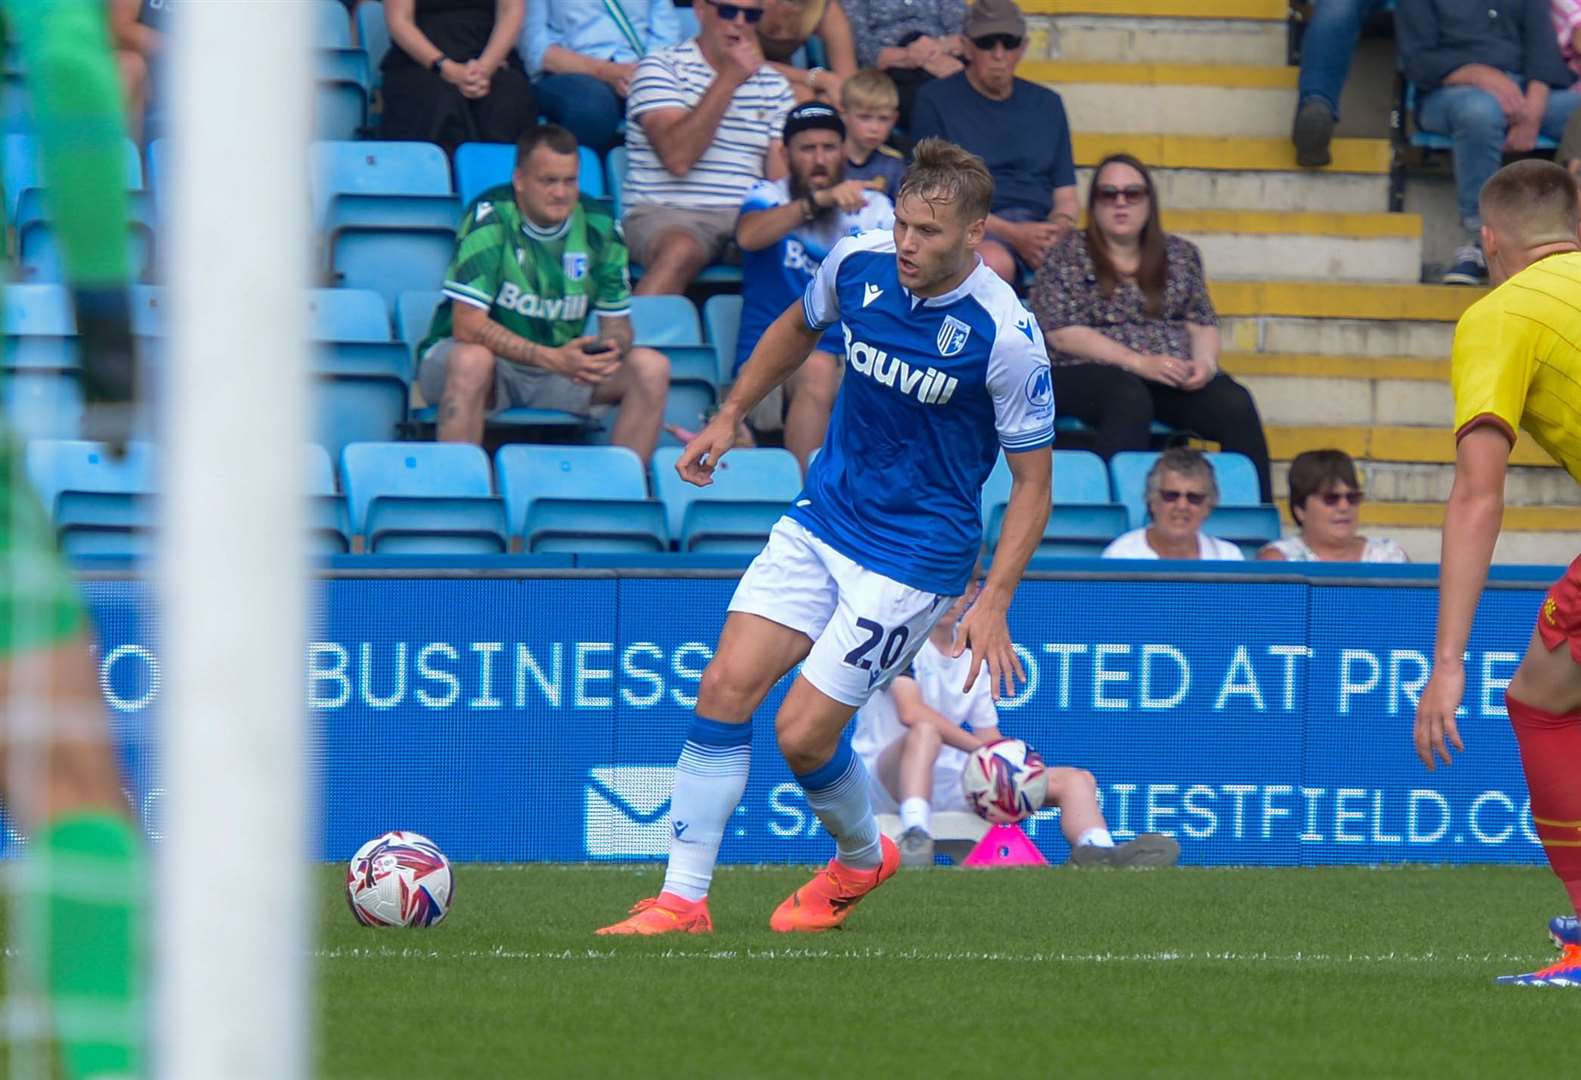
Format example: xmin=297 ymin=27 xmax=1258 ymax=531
xmin=1072 ymin=132 xmax=1390 ymax=213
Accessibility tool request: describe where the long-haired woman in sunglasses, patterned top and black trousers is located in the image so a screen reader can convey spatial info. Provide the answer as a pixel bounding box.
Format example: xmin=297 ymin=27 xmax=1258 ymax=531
xmin=1031 ymin=153 xmax=1273 ymax=503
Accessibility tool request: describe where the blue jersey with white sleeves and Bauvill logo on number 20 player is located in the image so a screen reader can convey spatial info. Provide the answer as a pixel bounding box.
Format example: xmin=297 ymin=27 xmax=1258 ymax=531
xmin=791 ymin=231 xmax=1055 ymax=596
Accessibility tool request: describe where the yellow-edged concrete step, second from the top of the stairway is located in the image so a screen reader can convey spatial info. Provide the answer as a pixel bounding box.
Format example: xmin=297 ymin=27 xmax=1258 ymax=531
xmin=1017 ymin=60 xmax=1298 ymax=138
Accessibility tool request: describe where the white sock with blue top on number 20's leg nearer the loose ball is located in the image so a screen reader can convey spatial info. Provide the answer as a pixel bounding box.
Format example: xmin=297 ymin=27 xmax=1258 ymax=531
xmin=664 ymin=716 xmax=753 ymax=900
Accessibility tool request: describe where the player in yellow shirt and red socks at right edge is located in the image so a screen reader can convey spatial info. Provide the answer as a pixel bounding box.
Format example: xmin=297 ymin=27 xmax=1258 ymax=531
xmin=1415 ymin=160 xmax=1581 ymax=985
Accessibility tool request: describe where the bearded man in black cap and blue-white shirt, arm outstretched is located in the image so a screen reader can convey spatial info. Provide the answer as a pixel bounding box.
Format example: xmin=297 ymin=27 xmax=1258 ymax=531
xmin=735 ymin=101 xmax=895 ymax=470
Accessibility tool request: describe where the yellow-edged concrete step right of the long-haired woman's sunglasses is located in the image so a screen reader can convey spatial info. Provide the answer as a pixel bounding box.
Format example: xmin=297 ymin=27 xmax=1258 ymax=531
xmin=1164 ymin=209 xmax=1421 ymax=283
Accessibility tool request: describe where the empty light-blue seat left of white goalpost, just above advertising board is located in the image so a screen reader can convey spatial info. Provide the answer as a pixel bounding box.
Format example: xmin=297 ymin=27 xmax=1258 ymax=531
xmin=24 ymin=440 xmax=158 ymax=557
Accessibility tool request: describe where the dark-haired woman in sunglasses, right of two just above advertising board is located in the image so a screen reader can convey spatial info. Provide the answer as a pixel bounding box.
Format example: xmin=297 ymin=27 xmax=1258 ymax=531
xmin=1257 ymin=451 xmax=1410 ymax=563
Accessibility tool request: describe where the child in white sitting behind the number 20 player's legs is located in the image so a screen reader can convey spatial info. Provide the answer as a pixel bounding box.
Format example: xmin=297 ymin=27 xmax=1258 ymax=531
xmin=851 ymin=591 xmax=1181 ymax=867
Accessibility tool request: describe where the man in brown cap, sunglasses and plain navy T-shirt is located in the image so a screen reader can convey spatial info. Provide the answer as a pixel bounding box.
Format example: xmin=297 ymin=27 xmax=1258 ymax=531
xmin=911 ymin=0 xmax=1077 ymax=285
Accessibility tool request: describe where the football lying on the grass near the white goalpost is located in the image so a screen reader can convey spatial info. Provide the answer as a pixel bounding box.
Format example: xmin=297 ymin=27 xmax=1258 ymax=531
xmin=346 ymin=832 xmax=451 ymax=927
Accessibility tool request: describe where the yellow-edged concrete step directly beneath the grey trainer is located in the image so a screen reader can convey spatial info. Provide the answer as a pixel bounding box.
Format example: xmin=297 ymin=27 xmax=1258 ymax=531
xmin=1208 ymin=281 xmax=1486 ymax=359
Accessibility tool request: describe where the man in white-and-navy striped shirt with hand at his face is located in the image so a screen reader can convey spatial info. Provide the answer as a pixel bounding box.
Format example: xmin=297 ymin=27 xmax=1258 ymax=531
xmin=623 ymin=0 xmax=795 ymax=294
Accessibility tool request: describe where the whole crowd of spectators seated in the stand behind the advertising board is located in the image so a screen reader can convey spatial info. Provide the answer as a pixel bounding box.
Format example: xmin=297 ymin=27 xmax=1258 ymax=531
xmin=77 ymin=0 xmax=1581 ymax=558
